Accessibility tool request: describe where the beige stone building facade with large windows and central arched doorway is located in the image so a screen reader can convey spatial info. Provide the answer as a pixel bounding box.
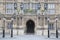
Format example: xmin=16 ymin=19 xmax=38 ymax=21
xmin=0 ymin=0 xmax=60 ymax=35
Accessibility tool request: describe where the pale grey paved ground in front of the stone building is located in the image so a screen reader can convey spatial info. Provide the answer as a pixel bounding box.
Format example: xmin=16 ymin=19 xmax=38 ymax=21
xmin=0 ymin=35 xmax=60 ymax=40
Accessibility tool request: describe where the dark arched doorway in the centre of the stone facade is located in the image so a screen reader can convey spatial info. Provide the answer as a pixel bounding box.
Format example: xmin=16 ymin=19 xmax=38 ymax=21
xmin=26 ymin=20 xmax=35 ymax=34
